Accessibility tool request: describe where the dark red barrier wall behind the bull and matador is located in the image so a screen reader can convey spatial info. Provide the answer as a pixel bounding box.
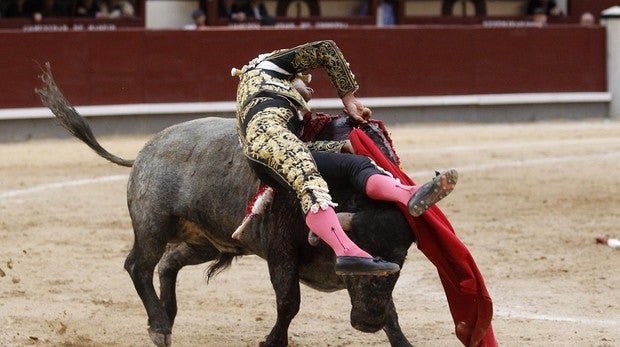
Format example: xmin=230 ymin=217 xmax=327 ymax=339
xmin=0 ymin=26 xmax=606 ymax=108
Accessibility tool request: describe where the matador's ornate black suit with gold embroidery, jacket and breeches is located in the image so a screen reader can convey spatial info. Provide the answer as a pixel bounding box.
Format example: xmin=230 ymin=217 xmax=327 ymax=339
xmin=237 ymin=40 xmax=358 ymax=214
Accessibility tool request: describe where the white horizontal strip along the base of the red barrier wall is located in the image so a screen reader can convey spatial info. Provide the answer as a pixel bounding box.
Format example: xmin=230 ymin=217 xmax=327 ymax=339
xmin=0 ymin=92 xmax=611 ymax=120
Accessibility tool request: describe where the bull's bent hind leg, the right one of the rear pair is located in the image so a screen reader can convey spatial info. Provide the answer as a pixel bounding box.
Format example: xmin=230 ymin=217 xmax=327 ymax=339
xmin=157 ymin=241 xmax=219 ymax=327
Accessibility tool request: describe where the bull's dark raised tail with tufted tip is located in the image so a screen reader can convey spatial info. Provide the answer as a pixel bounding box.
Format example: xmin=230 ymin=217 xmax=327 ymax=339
xmin=34 ymin=62 xmax=134 ymax=167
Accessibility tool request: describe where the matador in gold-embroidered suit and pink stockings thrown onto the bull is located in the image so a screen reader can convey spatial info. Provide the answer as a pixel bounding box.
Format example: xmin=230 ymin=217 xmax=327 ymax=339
xmin=233 ymin=40 xmax=457 ymax=275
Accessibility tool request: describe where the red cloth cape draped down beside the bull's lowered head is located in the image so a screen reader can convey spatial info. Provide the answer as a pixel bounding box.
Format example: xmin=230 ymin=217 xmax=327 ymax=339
xmin=350 ymin=129 xmax=497 ymax=347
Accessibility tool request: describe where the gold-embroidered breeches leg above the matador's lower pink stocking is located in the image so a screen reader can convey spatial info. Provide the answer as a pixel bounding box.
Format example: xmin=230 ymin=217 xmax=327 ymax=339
xmin=244 ymin=107 xmax=333 ymax=214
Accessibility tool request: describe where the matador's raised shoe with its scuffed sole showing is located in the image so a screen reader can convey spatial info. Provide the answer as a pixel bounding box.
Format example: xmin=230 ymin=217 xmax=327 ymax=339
xmin=407 ymin=169 xmax=459 ymax=217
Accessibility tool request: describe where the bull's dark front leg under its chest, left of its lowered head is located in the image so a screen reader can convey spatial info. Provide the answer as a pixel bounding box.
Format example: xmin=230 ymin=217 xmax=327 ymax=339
xmin=261 ymin=239 xmax=301 ymax=347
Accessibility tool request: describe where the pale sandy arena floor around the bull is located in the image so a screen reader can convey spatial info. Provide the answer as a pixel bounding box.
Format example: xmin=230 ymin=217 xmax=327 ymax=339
xmin=0 ymin=120 xmax=620 ymax=347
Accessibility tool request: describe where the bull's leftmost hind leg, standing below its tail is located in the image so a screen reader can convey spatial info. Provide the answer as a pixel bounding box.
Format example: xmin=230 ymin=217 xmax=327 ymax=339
xmin=125 ymin=221 xmax=177 ymax=347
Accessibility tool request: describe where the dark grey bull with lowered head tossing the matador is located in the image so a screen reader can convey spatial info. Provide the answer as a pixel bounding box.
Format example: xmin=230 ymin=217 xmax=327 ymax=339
xmin=37 ymin=66 xmax=415 ymax=346
